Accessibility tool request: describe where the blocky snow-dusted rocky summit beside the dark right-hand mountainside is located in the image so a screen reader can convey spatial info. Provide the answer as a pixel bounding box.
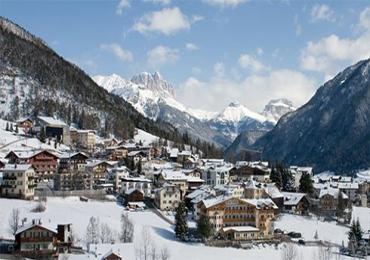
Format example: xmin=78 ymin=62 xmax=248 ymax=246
xmin=262 ymin=98 xmax=296 ymax=123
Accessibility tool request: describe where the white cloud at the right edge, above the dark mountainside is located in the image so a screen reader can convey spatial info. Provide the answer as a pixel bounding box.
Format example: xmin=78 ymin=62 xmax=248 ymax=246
xmin=300 ymin=7 xmax=370 ymax=79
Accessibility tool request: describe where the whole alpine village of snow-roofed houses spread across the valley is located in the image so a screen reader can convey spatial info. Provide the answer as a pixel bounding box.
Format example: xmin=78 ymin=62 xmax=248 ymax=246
xmin=0 ymin=116 xmax=370 ymax=259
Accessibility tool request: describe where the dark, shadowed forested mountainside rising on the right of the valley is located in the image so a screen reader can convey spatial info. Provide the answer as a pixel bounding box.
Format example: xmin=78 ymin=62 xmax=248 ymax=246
xmin=254 ymin=60 xmax=370 ymax=173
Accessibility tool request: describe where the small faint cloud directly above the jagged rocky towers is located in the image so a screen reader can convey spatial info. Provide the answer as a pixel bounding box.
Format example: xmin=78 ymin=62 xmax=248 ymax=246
xmin=147 ymin=45 xmax=179 ymax=68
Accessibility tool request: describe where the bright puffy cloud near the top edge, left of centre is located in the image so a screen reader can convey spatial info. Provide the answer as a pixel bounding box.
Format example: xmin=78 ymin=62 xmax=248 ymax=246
xmin=132 ymin=7 xmax=192 ymax=35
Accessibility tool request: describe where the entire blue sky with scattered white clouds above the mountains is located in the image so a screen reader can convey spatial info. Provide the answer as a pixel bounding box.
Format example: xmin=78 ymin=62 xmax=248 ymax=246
xmin=0 ymin=0 xmax=370 ymax=111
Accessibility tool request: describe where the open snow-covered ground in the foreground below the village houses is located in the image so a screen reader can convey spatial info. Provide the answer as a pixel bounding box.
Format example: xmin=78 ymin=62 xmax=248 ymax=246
xmin=0 ymin=197 xmax=364 ymax=260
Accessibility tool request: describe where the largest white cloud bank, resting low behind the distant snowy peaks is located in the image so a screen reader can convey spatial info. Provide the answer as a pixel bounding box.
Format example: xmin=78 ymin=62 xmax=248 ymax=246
xmin=177 ymin=66 xmax=315 ymax=111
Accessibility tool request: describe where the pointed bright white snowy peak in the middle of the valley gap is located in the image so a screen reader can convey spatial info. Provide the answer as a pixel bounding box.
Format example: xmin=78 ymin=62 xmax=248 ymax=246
xmin=216 ymin=102 xmax=266 ymax=122
